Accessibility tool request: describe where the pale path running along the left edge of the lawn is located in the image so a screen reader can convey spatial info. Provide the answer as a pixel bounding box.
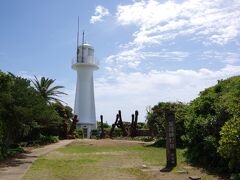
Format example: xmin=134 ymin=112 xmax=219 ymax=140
xmin=0 ymin=140 xmax=73 ymax=180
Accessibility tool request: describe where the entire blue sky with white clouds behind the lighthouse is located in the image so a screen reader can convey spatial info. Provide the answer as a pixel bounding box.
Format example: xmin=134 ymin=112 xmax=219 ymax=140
xmin=0 ymin=0 xmax=240 ymax=123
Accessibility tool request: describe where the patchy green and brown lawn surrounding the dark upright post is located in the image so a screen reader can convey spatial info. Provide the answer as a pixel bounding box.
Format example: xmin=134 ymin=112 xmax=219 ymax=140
xmin=23 ymin=140 xmax=221 ymax=180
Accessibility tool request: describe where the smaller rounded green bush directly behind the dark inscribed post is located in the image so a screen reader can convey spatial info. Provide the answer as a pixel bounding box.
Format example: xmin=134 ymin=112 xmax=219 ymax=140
xmin=147 ymin=102 xmax=188 ymax=146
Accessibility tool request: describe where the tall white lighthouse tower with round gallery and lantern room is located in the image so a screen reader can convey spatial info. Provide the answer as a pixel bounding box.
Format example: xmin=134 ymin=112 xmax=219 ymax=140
xmin=72 ymin=33 xmax=98 ymax=138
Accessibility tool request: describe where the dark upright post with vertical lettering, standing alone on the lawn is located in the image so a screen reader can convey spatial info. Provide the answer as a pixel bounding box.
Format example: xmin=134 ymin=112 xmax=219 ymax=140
xmin=165 ymin=110 xmax=177 ymax=168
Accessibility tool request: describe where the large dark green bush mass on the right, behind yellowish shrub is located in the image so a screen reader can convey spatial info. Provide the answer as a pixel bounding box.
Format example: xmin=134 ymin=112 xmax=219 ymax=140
xmin=184 ymin=76 xmax=240 ymax=172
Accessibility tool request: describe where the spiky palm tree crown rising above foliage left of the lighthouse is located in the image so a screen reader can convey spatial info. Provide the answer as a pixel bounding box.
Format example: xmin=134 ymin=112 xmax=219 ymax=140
xmin=32 ymin=76 xmax=67 ymax=103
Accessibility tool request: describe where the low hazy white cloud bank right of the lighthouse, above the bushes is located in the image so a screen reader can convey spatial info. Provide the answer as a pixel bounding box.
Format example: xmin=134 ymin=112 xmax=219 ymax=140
xmin=95 ymin=65 xmax=240 ymax=122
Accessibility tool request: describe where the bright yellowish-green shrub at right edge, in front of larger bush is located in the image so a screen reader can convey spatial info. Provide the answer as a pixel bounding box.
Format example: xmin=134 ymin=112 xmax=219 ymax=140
xmin=218 ymin=117 xmax=240 ymax=172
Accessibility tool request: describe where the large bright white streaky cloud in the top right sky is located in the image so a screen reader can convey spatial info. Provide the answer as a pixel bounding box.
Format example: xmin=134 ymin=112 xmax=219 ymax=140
xmin=116 ymin=0 xmax=240 ymax=45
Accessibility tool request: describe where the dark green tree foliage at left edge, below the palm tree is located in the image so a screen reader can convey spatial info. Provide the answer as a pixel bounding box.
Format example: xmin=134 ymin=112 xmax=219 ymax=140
xmin=0 ymin=71 xmax=61 ymax=158
